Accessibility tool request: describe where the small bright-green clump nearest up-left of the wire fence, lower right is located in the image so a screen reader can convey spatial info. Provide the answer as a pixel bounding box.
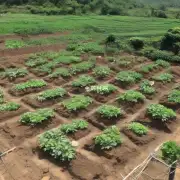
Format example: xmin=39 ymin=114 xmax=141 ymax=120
xmin=128 ymin=122 xmax=149 ymax=136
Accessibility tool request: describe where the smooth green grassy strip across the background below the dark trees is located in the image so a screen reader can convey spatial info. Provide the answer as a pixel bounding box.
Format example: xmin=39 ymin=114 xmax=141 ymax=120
xmin=0 ymin=14 xmax=180 ymax=37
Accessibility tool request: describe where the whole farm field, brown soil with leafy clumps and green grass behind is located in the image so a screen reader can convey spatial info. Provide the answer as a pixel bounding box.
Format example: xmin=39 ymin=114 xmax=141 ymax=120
xmin=0 ymin=15 xmax=180 ymax=180
